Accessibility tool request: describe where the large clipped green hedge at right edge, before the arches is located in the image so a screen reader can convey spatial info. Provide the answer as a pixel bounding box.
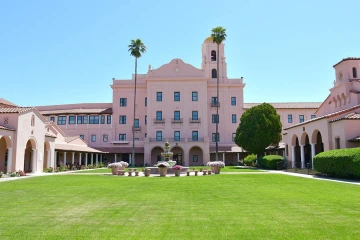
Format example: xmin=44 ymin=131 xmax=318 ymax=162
xmin=314 ymin=148 xmax=360 ymax=178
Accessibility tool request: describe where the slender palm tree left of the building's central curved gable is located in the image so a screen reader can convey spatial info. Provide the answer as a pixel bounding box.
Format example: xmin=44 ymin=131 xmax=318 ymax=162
xmin=128 ymin=39 xmax=146 ymax=167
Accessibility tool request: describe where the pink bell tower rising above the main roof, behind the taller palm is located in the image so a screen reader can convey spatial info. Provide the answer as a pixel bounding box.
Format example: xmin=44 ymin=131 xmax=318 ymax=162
xmin=201 ymin=37 xmax=227 ymax=79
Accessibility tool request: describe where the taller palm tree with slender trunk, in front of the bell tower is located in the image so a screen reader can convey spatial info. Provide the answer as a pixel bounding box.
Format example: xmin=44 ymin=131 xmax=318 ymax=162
xmin=211 ymin=26 xmax=226 ymax=161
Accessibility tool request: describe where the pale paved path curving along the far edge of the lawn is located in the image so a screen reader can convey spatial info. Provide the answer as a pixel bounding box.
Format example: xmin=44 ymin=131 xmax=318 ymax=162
xmin=0 ymin=169 xmax=360 ymax=186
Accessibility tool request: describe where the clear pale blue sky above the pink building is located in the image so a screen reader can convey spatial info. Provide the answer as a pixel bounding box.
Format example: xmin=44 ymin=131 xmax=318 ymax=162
xmin=0 ymin=0 xmax=360 ymax=106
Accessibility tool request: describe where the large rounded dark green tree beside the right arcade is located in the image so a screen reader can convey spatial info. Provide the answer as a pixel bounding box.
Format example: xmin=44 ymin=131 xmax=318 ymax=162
xmin=235 ymin=103 xmax=282 ymax=154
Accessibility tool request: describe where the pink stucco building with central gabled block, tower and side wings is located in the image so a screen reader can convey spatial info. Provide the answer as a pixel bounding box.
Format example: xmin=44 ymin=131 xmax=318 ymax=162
xmin=0 ymin=38 xmax=360 ymax=171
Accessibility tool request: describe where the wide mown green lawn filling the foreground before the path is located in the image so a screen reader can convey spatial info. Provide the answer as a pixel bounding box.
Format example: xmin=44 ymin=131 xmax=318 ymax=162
xmin=0 ymin=174 xmax=360 ymax=239
